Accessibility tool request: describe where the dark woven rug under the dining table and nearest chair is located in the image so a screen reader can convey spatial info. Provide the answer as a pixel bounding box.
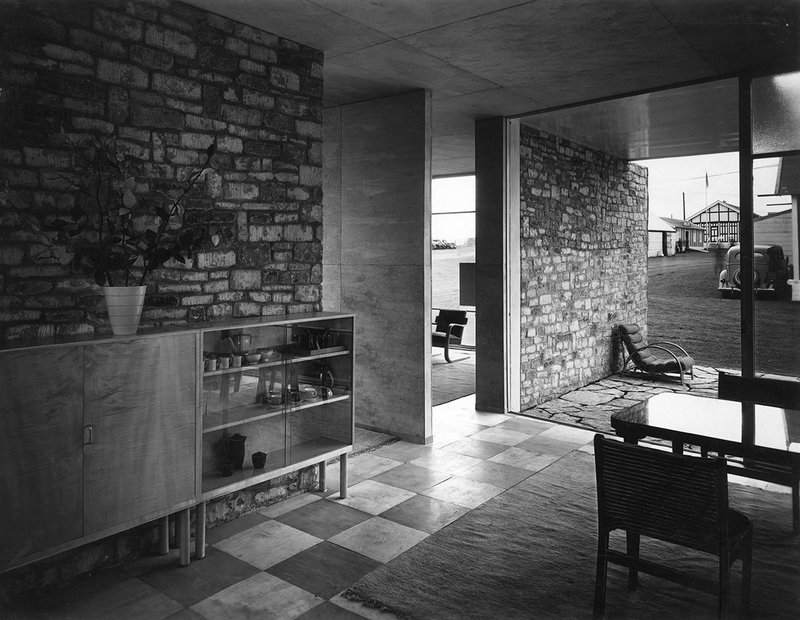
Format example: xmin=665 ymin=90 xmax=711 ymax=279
xmin=345 ymin=452 xmax=800 ymax=619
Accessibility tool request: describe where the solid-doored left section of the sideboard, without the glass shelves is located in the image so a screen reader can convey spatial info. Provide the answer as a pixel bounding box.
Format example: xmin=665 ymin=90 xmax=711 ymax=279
xmin=0 ymin=333 xmax=197 ymax=571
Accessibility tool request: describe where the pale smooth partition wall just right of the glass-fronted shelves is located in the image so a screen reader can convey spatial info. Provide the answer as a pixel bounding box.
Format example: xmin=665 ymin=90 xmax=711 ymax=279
xmin=323 ymin=91 xmax=433 ymax=443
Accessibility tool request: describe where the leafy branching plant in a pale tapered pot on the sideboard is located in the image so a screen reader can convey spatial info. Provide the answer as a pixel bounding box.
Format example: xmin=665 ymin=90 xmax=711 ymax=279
xmin=0 ymin=133 xmax=217 ymax=335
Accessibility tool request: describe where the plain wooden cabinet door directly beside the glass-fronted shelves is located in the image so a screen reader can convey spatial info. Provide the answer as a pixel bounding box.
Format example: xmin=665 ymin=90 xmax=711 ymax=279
xmin=84 ymin=334 xmax=197 ymax=534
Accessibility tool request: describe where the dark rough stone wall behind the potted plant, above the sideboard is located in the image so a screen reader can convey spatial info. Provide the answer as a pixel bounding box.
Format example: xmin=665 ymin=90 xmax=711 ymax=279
xmin=0 ymin=0 xmax=322 ymax=339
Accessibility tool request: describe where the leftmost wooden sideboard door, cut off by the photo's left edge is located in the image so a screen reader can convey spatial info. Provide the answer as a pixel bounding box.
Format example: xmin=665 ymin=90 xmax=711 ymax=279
xmin=0 ymin=347 xmax=83 ymax=570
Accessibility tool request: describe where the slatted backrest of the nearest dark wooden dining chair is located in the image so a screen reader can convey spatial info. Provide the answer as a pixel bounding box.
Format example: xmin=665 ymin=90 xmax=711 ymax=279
xmin=595 ymin=435 xmax=728 ymax=553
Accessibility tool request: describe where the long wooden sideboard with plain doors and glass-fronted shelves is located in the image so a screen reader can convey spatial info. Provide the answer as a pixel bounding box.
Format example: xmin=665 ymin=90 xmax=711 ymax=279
xmin=0 ymin=312 xmax=354 ymax=572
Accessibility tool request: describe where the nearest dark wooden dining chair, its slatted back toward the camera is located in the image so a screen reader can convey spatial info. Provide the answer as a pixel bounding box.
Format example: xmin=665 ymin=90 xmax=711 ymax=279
xmin=594 ymin=434 xmax=753 ymax=618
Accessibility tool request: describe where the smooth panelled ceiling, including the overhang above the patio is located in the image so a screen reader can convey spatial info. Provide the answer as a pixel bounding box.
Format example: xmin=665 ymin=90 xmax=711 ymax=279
xmin=183 ymin=0 xmax=800 ymax=175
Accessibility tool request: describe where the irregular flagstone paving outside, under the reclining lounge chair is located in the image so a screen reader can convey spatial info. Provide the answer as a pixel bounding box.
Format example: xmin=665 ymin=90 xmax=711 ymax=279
xmin=521 ymin=366 xmax=720 ymax=433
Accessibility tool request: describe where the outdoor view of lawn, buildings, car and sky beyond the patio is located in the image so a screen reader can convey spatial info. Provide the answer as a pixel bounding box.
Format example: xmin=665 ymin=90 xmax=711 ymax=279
xmin=636 ymin=153 xmax=800 ymax=376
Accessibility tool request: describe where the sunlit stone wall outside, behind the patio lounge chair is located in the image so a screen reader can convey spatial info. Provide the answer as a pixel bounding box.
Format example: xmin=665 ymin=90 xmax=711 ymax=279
xmin=520 ymin=125 xmax=647 ymax=409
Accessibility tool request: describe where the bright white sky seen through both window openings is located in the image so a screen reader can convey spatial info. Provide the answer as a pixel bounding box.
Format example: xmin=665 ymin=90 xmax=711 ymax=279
xmin=431 ymin=153 xmax=791 ymax=243
